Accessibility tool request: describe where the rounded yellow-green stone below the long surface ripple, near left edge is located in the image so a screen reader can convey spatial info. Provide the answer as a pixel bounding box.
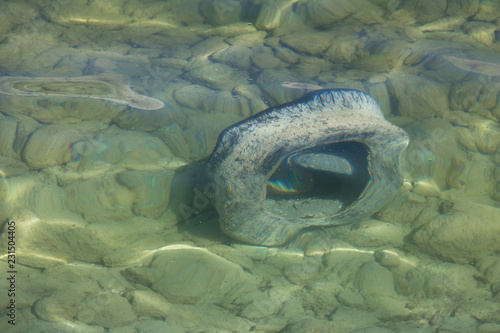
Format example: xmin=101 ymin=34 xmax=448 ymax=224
xmin=22 ymin=125 xmax=84 ymax=170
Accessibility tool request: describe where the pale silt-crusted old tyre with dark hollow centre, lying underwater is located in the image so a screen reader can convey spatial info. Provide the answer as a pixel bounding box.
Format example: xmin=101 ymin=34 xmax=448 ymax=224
xmin=207 ymin=90 xmax=408 ymax=245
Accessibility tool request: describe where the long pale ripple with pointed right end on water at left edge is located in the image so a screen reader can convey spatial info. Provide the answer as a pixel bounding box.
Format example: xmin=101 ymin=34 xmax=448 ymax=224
xmin=0 ymin=74 xmax=165 ymax=110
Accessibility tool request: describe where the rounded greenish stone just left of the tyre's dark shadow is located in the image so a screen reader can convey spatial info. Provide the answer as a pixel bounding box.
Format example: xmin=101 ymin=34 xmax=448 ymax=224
xmin=116 ymin=170 xmax=174 ymax=218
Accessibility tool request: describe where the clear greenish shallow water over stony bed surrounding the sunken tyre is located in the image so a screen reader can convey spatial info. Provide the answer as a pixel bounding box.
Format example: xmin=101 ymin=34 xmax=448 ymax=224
xmin=0 ymin=0 xmax=500 ymax=332
